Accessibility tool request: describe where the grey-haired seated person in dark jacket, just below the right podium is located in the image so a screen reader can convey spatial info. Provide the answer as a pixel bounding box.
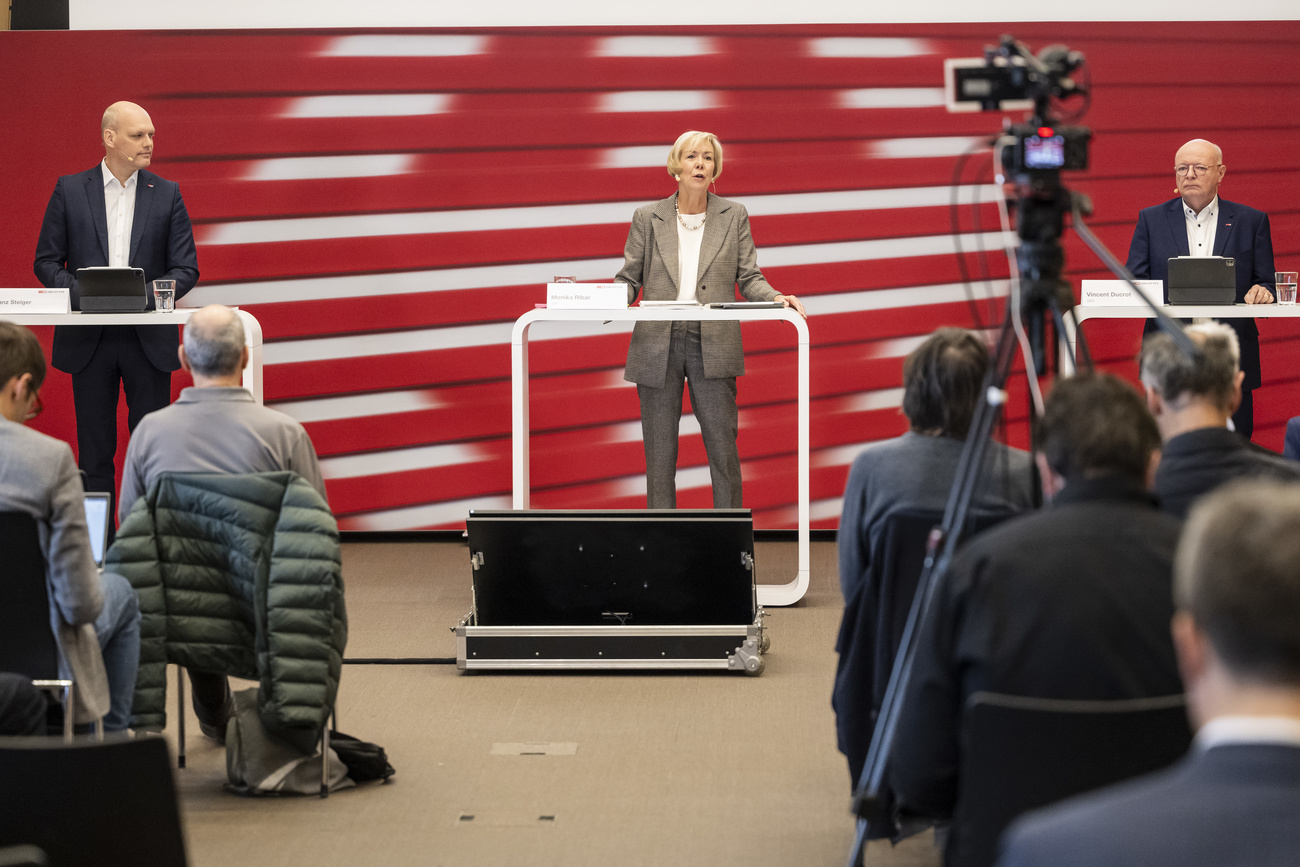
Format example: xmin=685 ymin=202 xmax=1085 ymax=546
xmin=1140 ymin=322 xmax=1300 ymax=517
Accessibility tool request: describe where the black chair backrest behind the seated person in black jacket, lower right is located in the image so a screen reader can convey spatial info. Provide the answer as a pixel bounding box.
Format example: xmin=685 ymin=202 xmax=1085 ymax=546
xmin=945 ymin=693 xmax=1192 ymax=867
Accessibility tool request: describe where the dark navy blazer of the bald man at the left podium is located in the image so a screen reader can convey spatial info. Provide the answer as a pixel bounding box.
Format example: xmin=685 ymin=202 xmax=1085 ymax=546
xmin=34 ymin=165 xmax=199 ymax=373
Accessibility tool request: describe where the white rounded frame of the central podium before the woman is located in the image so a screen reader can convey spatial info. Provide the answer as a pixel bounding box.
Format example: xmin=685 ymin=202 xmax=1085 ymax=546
xmin=510 ymin=307 xmax=810 ymax=606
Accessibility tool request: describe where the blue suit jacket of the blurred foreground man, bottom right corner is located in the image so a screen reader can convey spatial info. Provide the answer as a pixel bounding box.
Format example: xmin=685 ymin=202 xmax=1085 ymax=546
xmin=998 ymin=744 xmax=1300 ymax=867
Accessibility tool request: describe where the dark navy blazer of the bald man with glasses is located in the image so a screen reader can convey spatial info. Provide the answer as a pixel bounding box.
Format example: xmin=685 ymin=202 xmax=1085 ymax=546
xmin=1128 ymin=196 xmax=1274 ymax=391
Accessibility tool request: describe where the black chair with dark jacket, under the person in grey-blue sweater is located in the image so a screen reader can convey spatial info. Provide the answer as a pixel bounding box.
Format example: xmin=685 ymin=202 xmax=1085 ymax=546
xmin=831 ymin=510 xmax=1010 ymax=795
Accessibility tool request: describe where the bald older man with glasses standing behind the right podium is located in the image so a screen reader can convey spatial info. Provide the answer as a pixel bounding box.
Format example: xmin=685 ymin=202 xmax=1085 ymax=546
xmin=1128 ymin=139 xmax=1274 ymax=439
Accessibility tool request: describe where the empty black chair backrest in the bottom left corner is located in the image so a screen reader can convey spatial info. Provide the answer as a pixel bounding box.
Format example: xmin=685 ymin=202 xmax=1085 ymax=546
xmin=0 ymin=737 xmax=186 ymax=867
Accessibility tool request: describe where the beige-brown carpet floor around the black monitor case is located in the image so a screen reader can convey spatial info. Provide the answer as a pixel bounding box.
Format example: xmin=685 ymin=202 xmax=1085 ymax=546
xmin=166 ymin=542 xmax=939 ymax=867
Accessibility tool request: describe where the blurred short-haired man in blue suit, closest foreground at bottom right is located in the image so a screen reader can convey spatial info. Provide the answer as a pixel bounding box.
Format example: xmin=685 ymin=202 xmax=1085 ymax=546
xmin=1001 ymin=480 xmax=1300 ymax=867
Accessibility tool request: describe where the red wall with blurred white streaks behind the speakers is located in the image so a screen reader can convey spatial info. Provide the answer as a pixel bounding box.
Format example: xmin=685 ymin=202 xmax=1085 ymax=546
xmin=0 ymin=22 xmax=1300 ymax=529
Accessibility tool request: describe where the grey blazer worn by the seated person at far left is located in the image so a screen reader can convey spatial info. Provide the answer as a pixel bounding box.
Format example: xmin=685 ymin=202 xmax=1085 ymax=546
xmin=0 ymin=417 xmax=108 ymax=723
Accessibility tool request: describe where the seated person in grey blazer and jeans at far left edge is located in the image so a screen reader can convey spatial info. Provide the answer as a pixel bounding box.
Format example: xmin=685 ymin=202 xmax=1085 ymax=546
xmin=0 ymin=322 xmax=140 ymax=732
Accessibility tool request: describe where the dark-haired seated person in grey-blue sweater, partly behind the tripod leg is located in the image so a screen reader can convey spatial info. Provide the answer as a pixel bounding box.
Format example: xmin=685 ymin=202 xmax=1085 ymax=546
xmin=839 ymin=328 xmax=1034 ymax=601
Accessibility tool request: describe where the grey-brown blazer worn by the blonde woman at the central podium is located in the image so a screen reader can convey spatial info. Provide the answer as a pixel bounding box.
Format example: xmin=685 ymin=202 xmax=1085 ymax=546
xmin=615 ymin=194 xmax=780 ymax=389
